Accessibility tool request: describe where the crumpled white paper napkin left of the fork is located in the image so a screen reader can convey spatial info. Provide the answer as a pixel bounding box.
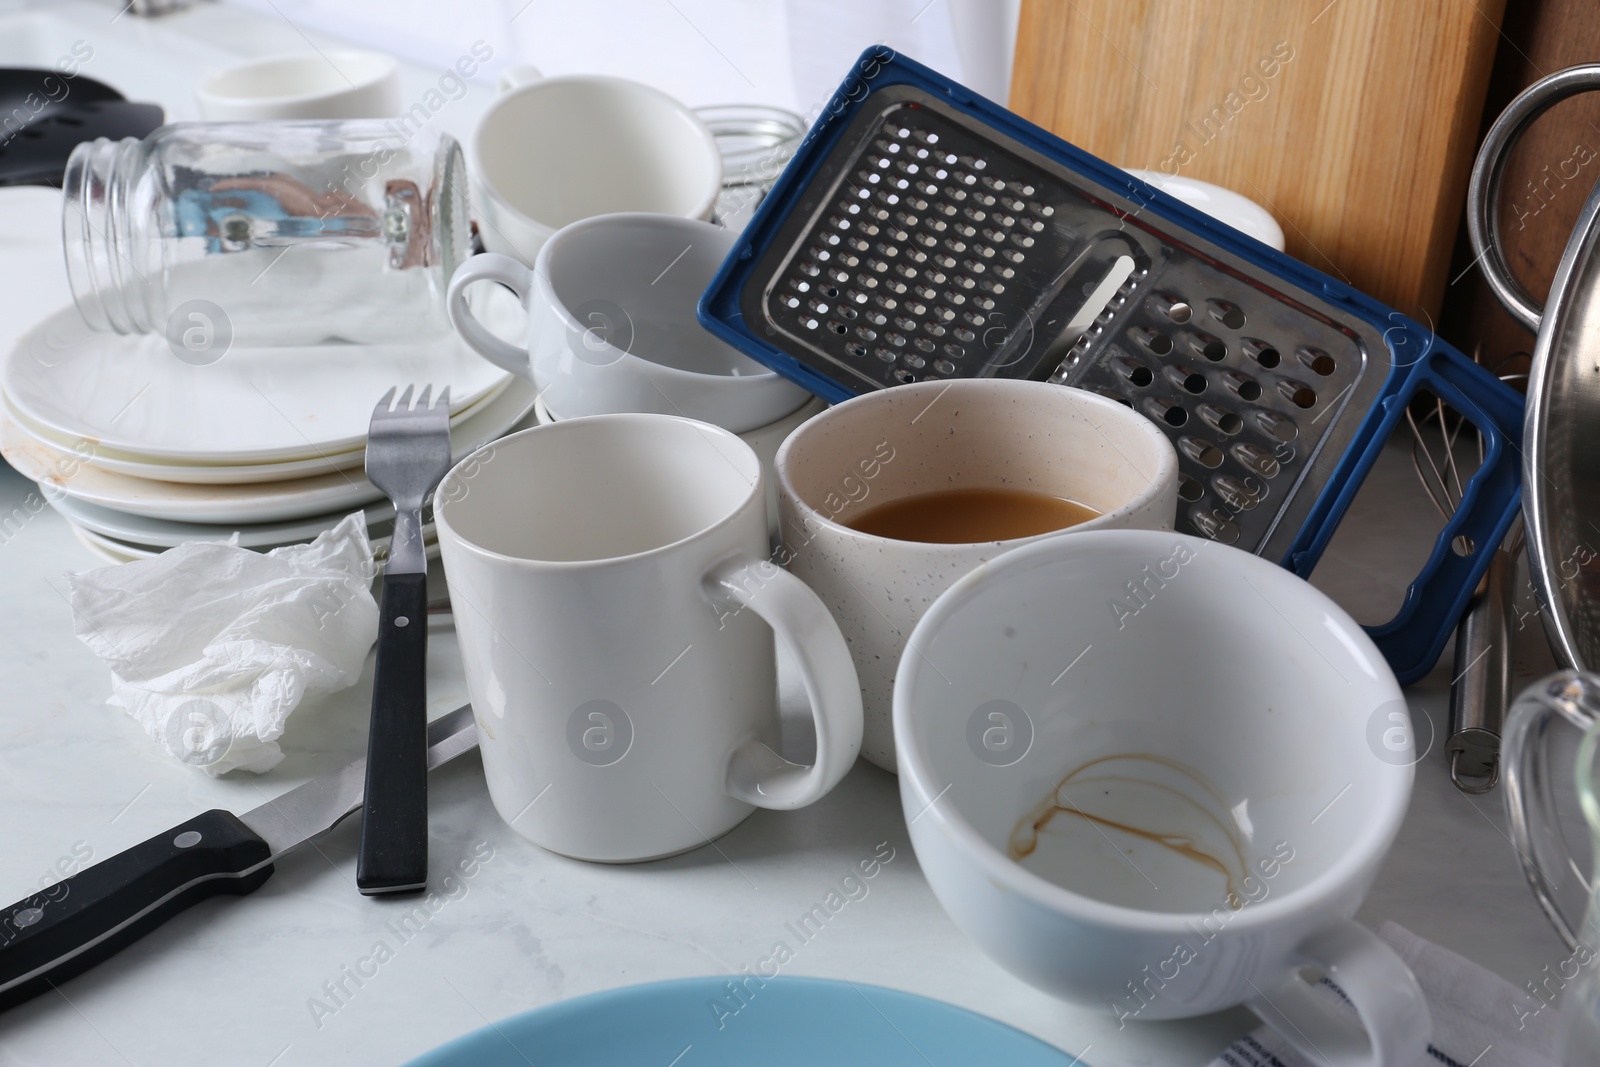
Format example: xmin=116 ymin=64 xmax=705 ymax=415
xmin=67 ymin=512 xmax=378 ymax=776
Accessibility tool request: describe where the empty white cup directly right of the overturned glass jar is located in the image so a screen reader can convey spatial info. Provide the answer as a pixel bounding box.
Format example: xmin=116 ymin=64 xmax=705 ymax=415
xmin=467 ymin=67 xmax=722 ymax=264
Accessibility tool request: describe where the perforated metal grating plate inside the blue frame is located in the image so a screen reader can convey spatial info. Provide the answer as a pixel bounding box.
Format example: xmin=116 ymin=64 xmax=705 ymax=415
xmin=746 ymin=86 xmax=1384 ymax=555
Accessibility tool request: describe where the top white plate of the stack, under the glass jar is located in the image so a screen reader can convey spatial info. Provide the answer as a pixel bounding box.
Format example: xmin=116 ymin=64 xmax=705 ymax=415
xmin=0 ymin=300 xmax=507 ymax=467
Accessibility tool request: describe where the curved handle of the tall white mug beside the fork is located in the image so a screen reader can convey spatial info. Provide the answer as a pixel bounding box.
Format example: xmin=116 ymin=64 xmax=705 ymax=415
xmin=701 ymin=557 xmax=861 ymax=809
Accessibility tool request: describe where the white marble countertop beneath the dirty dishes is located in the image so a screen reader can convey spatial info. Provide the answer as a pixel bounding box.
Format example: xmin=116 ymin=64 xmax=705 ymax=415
xmin=0 ymin=4 xmax=1566 ymax=1067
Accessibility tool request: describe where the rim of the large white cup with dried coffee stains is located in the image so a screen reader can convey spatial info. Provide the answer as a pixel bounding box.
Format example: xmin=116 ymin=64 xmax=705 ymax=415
xmin=894 ymin=530 xmax=1414 ymax=937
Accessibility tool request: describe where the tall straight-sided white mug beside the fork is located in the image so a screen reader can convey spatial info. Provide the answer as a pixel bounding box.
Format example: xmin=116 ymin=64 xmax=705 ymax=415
xmin=434 ymin=414 xmax=861 ymax=862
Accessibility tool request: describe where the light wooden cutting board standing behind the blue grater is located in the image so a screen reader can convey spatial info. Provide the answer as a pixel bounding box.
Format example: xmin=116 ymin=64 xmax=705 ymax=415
xmin=1011 ymin=0 xmax=1504 ymax=322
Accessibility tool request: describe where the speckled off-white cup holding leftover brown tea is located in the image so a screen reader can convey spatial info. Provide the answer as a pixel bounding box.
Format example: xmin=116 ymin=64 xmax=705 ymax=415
xmin=774 ymin=378 xmax=1178 ymax=771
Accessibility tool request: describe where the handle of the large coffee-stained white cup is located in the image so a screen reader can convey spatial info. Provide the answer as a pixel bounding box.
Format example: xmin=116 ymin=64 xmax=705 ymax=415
xmin=1245 ymin=918 xmax=1434 ymax=1067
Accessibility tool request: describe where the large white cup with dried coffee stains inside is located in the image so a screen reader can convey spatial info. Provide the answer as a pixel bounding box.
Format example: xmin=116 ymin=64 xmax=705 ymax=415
xmin=894 ymin=530 xmax=1430 ymax=1067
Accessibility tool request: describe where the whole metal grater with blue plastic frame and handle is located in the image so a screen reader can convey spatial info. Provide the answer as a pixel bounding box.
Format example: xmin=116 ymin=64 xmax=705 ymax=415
xmin=699 ymin=46 xmax=1523 ymax=683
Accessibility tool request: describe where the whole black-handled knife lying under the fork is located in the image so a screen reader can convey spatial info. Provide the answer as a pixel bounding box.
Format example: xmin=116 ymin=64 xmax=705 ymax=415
xmin=0 ymin=704 xmax=478 ymax=1011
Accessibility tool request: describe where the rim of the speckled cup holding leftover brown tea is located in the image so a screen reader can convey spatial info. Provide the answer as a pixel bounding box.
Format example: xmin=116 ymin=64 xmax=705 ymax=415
xmin=773 ymin=378 xmax=1178 ymax=552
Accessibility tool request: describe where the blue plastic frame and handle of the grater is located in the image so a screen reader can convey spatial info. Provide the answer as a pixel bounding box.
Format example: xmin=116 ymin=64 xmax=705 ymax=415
xmin=699 ymin=46 xmax=1523 ymax=683
